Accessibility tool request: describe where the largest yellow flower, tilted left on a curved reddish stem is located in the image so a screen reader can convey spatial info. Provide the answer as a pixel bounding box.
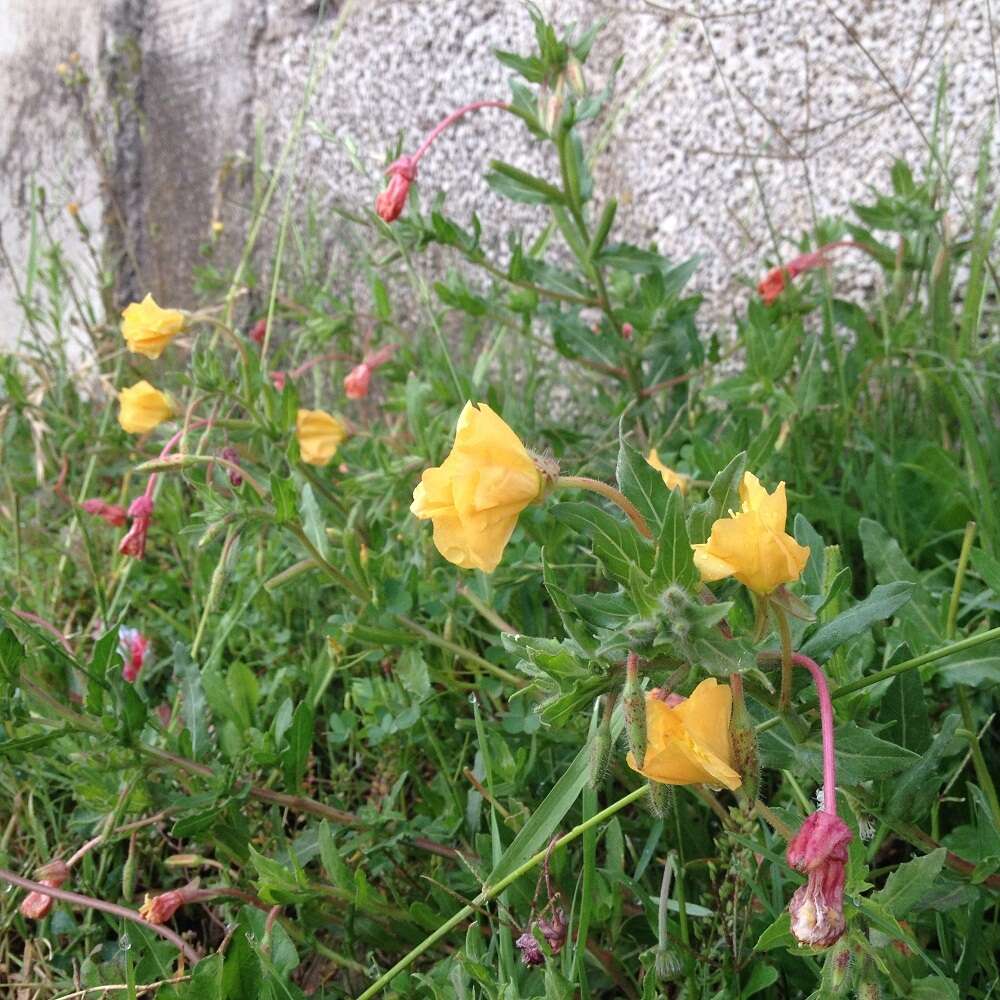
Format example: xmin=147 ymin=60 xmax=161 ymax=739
xmin=410 ymin=403 xmax=542 ymax=573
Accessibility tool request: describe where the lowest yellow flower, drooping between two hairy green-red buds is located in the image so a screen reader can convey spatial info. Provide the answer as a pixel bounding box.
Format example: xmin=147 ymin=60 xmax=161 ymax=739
xmin=628 ymin=677 xmax=743 ymax=789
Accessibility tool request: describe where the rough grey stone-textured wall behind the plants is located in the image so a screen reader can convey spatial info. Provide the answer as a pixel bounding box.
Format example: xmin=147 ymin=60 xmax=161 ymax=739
xmin=0 ymin=0 xmax=1000 ymax=352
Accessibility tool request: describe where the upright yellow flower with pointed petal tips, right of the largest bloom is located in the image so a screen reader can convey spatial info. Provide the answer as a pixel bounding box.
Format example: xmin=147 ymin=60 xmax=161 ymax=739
xmin=691 ymin=472 xmax=809 ymax=594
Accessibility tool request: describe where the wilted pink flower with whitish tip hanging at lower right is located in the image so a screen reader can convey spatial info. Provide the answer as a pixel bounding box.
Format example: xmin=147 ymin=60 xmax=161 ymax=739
xmin=785 ymin=811 xmax=854 ymax=948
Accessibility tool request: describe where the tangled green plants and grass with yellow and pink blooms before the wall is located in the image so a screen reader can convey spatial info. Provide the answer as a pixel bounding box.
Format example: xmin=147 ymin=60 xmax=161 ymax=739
xmin=0 ymin=7 xmax=1000 ymax=1000
